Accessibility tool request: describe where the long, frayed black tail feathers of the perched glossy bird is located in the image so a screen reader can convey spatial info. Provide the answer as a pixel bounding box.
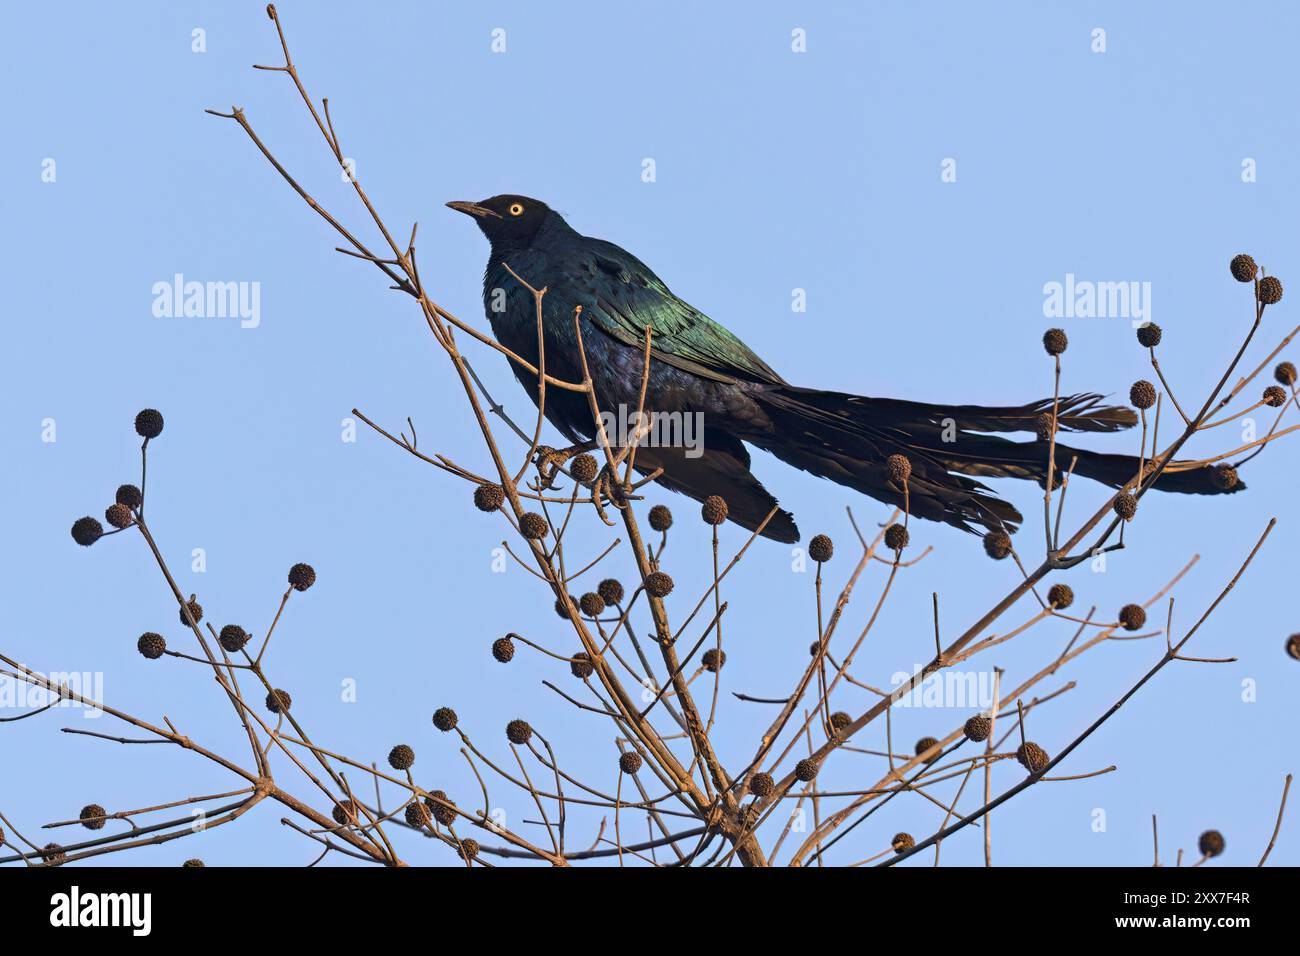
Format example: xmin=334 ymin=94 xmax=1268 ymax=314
xmin=742 ymin=386 xmax=1245 ymax=532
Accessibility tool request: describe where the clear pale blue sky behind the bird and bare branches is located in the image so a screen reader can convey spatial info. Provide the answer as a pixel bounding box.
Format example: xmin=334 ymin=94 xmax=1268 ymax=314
xmin=0 ymin=0 xmax=1300 ymax=865
